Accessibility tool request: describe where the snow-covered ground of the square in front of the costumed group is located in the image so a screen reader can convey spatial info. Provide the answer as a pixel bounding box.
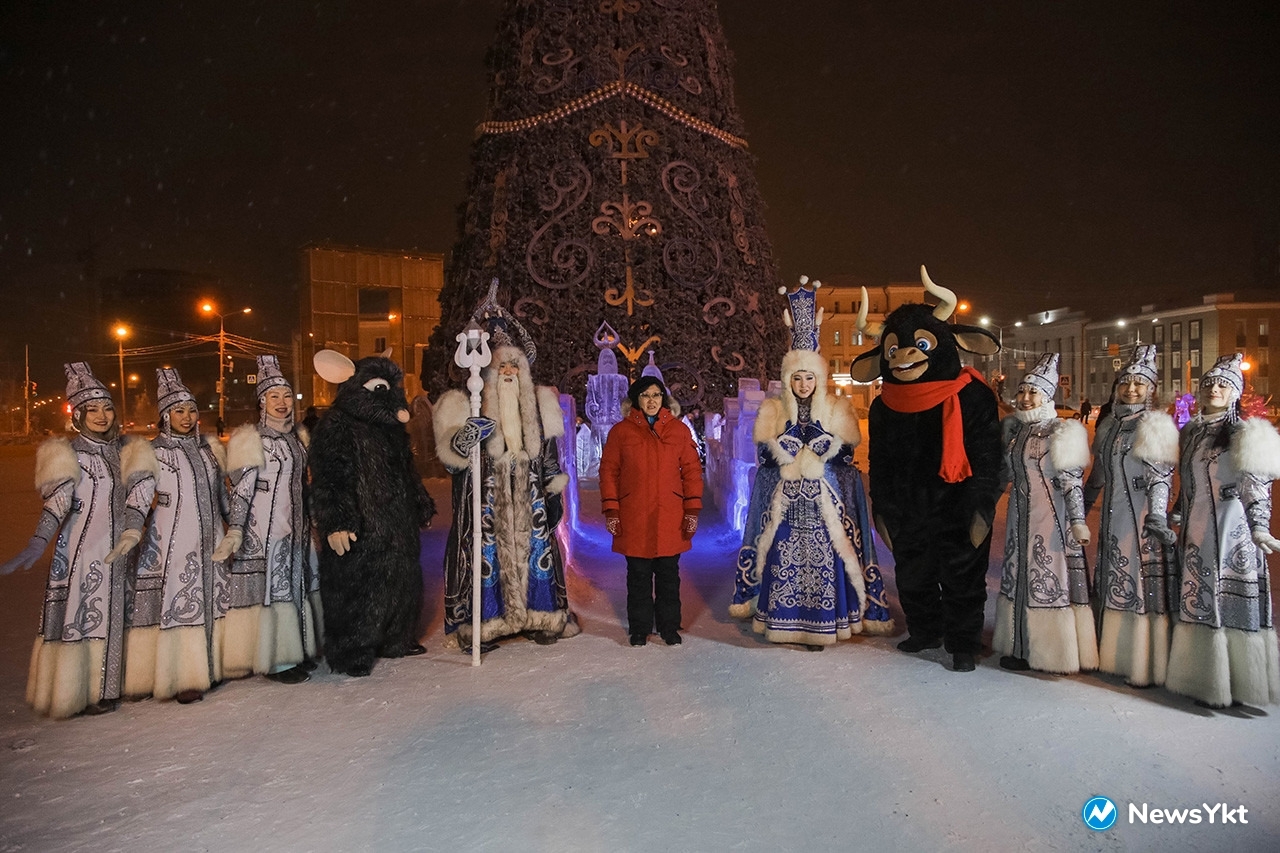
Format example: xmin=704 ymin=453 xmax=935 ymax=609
xmin=0 ymin=440 xmax=1280 ymax=853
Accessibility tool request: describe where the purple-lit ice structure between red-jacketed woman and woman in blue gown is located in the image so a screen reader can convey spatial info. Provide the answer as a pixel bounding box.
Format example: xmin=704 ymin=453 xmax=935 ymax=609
xmin=707 ymin=379 xmax=782 ymax=532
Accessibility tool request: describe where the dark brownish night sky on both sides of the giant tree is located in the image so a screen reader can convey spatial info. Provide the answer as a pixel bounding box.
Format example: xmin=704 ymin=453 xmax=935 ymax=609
xmin=0 ymin=0 xmax=1280 ymax=382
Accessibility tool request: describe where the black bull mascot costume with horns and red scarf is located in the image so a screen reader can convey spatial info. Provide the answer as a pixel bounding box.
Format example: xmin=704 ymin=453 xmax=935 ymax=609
xmin=851 ymin=266 xmax=1004 ymax=672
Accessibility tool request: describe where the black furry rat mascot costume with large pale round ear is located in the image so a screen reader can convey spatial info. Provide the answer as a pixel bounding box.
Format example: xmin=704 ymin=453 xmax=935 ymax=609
xmin=307 ymin=350 xmax=435 ymax=676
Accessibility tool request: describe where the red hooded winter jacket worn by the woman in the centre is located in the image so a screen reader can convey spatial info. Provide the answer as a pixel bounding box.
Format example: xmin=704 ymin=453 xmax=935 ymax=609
xmin=600 ymin=406 xmax=703 ymax=558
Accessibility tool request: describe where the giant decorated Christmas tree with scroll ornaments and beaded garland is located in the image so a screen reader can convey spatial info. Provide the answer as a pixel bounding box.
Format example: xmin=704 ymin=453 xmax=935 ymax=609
xmin=422 ymin=0 xmax=785 ymax=409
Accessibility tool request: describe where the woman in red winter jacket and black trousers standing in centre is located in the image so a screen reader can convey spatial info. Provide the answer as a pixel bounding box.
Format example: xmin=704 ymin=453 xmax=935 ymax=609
xmin=600 ymin=377 xmax=703 ymax=646
